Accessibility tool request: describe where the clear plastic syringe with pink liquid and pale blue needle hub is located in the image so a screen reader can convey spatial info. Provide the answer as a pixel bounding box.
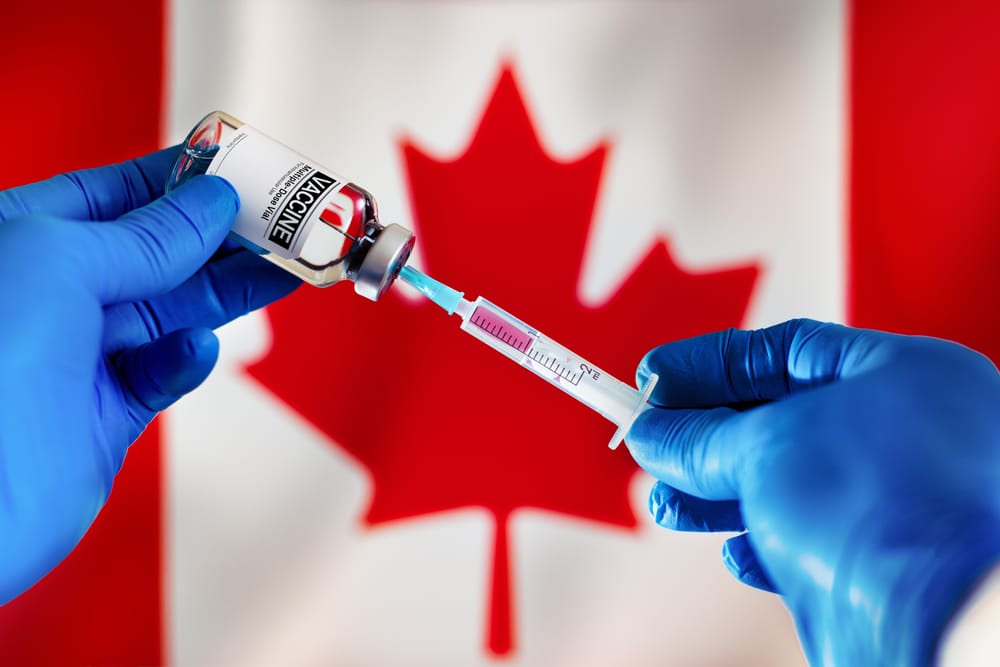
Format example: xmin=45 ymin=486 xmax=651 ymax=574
xmin=399 ymin=266 xmax=658 ymax=449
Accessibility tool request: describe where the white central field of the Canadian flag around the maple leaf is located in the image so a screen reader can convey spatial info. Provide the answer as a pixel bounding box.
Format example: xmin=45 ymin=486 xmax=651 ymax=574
xmin=165 ymin=0 xmax=845 ymax=667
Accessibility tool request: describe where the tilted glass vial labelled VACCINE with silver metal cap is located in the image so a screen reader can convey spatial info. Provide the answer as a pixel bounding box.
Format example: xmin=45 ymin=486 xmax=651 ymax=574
xmin=166 ymin=111 xmax=414 ymax=301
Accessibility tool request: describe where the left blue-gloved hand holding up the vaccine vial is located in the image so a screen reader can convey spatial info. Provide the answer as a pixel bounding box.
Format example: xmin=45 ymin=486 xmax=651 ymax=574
xmin=0 ymin=149 xmax=299 ymax=603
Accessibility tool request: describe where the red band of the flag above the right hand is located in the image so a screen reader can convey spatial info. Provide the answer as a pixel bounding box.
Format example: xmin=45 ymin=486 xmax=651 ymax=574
xmin=848 ymin=0 xmax=1000 ymax=361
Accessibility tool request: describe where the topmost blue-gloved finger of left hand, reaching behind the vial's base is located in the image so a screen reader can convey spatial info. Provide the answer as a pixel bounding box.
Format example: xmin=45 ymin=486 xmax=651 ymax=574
xmin=0 ymin=146 xmax=179 ymax=223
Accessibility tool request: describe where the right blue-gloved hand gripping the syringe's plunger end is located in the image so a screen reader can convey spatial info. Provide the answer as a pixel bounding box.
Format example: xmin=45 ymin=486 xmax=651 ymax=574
xmin=626 ymin=320 xmax=1000 ymax=667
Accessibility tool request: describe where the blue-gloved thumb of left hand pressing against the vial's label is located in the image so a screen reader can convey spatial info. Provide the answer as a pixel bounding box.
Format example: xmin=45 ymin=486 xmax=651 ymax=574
xmin=73 ymin=176 xmax=239 ymax=305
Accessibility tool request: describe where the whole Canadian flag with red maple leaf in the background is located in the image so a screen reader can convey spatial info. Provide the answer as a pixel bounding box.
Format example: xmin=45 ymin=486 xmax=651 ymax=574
xmin=0 ymin=0 xmax=1000 ymax=667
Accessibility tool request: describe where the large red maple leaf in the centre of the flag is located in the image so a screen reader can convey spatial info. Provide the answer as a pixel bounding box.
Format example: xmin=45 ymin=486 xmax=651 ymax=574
xmin=249 ymin=67 xmax=757 ymax=655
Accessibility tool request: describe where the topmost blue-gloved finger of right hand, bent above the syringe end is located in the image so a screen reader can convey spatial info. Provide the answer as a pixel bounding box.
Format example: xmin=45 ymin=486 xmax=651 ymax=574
xmin=636 ymin=319 xmax=904 ymax=408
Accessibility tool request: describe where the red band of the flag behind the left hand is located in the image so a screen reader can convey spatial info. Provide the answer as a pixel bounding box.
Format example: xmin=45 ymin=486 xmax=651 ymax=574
xmin=0 ymin=0 xmax=163 ymax=665
